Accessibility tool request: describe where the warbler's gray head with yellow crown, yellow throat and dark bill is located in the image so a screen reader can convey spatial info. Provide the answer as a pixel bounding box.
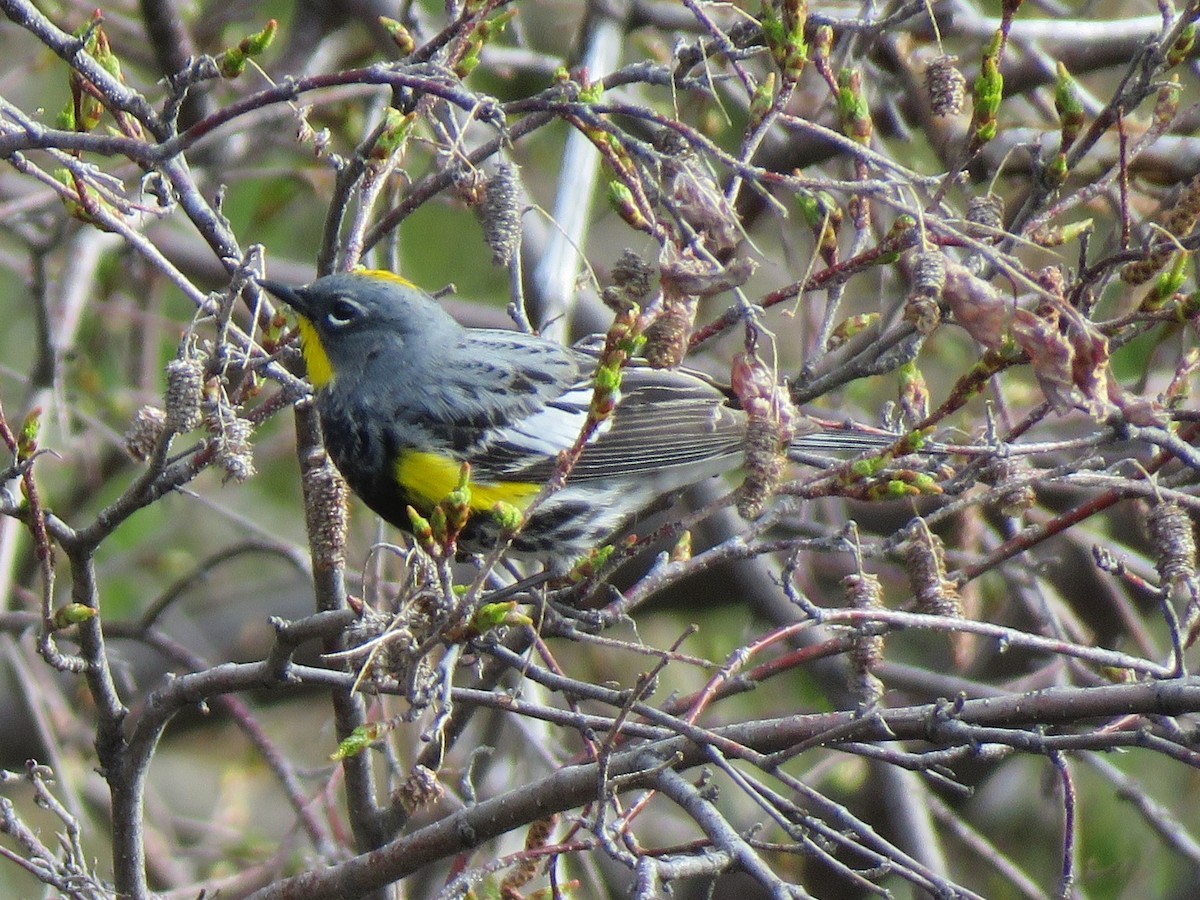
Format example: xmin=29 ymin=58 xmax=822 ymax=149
xmin=258 ymin=270 xmax=458 ymax=390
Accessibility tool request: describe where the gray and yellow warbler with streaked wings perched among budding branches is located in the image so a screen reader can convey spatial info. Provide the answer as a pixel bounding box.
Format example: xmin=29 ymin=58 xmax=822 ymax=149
xmin=259 ymin=271 xmax=881 ymax=565
